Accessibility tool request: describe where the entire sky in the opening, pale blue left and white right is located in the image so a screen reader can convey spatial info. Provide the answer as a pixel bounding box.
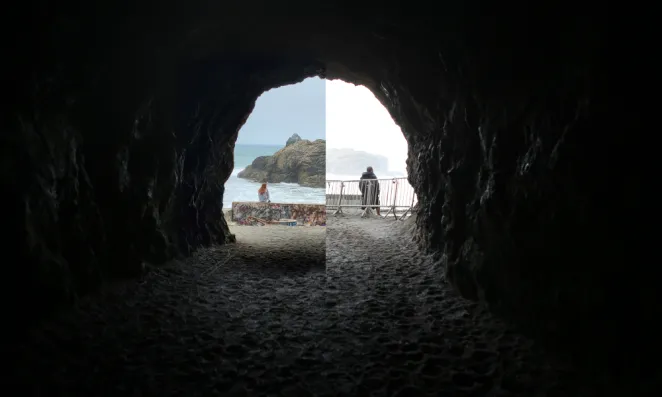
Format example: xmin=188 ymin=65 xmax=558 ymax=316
xmin=237 ymin=77 xmax=407 ymax=172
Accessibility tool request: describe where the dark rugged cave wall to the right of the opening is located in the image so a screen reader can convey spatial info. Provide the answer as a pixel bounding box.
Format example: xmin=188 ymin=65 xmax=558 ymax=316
xmin=373 ymin=13 xmax=661 ymax=371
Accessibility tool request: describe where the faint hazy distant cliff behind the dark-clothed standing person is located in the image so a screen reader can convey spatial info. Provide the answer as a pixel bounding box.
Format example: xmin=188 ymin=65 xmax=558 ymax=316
xmin=326 ymin=149 xmax=388 ymax=178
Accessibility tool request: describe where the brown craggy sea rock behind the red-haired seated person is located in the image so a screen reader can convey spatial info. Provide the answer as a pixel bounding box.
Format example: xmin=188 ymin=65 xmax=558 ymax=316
xmin=237 ymin=138 xmax=326 ymax=187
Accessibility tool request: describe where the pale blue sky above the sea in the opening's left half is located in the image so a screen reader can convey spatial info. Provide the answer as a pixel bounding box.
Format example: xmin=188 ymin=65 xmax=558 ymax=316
xmin=237 ymin=77 xmax=326 ymax=145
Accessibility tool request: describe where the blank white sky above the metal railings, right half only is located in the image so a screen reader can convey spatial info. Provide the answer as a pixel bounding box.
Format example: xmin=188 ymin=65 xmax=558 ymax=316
xmin=326 ymin=80 xmax=407 ymax=172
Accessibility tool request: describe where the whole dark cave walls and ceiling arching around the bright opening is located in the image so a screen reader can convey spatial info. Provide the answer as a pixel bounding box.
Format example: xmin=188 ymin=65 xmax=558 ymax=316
xmin=2 ymin=0 xmax=661 ymax=395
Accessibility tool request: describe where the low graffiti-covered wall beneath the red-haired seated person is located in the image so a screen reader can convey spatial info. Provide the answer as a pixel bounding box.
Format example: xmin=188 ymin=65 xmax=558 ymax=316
xmin=232 ymin=201 xmax=326 ymax=226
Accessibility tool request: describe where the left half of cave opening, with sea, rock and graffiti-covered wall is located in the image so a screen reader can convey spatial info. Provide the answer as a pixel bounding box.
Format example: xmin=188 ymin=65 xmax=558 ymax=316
xmin=223 ymin=78 xmax=326 ymax=232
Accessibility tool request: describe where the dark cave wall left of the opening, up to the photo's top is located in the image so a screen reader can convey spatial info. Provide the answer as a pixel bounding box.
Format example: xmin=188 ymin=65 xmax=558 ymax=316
xmin=1 ymin=3 xmax=320 ymax=324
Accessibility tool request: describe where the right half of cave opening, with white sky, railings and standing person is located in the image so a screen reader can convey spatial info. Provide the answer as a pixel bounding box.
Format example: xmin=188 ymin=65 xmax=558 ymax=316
xmin=326 ymin=80 xmax=416 ymax=218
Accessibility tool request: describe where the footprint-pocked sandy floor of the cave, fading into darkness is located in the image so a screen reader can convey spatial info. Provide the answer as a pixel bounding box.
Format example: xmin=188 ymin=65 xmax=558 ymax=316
xmin=9 ymin=216 xmax=636 ymax=397
